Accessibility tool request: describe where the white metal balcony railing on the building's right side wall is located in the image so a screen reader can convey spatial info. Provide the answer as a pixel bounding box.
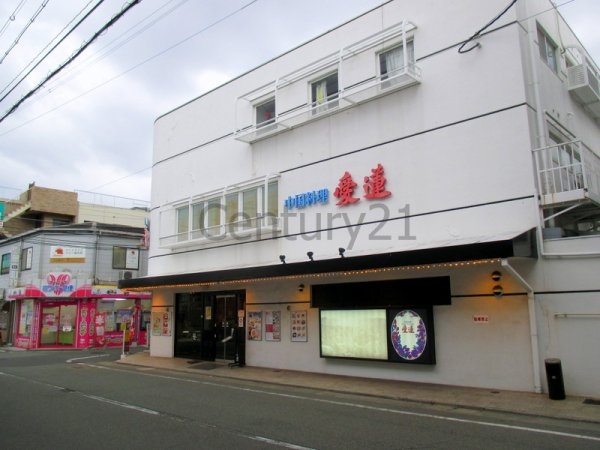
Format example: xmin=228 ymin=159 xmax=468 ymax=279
xmin=533 ymin=141 xmax=600 ymax=206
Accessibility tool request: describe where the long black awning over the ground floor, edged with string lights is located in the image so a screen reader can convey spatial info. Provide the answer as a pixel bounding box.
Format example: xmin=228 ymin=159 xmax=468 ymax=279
xmin=118 ymin=231 xmax=534 ymax=290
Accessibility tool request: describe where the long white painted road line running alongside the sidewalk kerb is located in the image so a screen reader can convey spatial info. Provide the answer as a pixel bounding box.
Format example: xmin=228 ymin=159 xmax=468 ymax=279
xmin=82 ymin=363 xmax=600 ymax=442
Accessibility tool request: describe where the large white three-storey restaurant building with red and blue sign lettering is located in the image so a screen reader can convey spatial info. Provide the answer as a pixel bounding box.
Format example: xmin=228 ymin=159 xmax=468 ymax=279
xmin=120 ymin=0 xmax=600 ymax=396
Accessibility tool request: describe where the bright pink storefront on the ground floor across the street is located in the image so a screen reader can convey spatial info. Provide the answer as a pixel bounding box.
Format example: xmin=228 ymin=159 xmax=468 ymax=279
xmin=8 ymin=277 xmax=151 ymax=349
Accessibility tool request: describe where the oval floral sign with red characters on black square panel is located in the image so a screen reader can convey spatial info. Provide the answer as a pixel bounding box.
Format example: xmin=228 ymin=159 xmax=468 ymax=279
xmin=387 ymin=307 xmax=435 ymax=364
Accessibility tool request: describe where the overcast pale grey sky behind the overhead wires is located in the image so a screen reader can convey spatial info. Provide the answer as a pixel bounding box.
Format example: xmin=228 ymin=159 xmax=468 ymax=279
xmin=0 ymin=0 xmax=600 ymax=201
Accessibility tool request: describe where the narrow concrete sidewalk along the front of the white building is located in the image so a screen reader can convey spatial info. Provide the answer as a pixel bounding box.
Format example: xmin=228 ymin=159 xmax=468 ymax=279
xmin=119 ymin=351 xmax=600 ymax=424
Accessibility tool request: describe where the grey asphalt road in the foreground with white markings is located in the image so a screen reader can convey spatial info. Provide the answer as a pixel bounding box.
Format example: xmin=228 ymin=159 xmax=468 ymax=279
xmin=0 ymin=349 xmax=600 ymax=450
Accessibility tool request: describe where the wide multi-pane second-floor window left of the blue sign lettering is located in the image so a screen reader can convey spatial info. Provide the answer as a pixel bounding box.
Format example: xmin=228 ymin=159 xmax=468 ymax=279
xmin=176 ymin=181 xmax=278 ymax=242
